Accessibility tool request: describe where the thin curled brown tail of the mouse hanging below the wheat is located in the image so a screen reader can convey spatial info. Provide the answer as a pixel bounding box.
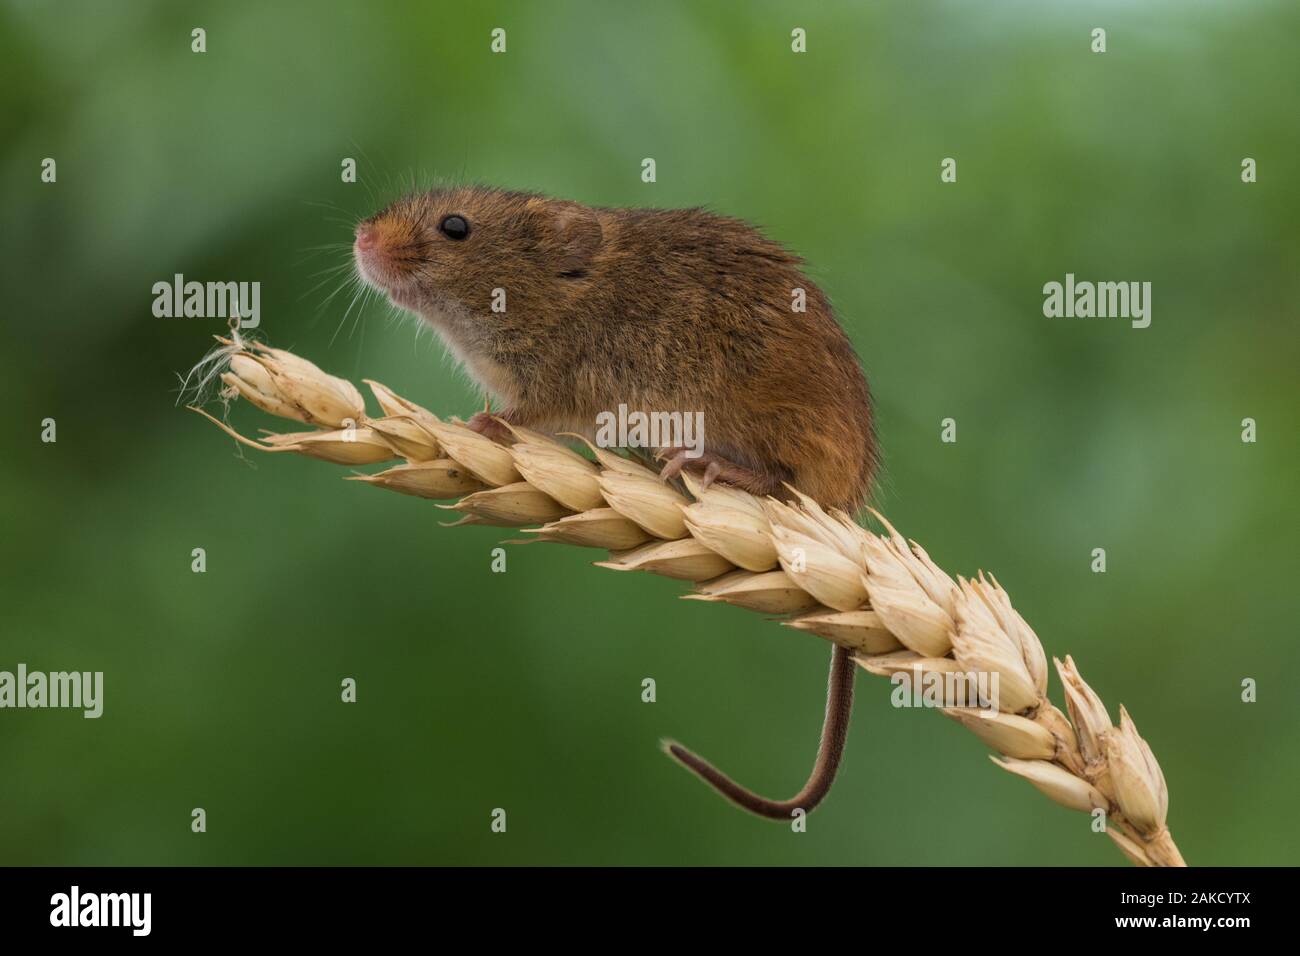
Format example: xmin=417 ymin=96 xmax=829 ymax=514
xmin=663 ymin=645 xmax=855 ymax=819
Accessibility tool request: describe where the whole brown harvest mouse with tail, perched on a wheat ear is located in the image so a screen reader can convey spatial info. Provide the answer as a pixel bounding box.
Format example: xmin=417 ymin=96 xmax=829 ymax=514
xmin=354 ymin=186 xmax=876 ymax=819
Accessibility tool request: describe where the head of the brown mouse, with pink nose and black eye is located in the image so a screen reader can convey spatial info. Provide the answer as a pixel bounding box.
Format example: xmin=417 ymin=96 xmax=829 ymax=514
xmin=352 ymin=186 xmax=602 ymax=320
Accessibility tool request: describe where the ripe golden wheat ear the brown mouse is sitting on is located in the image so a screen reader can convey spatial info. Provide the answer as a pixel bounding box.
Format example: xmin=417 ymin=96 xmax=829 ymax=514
xmin=194 ymin=338 xmax=1186 ymax=866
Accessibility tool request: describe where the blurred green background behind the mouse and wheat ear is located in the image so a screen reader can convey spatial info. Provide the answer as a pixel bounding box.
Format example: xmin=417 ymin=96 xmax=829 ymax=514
xmin=0 ymin=0 xmax=1300 ymax=865
